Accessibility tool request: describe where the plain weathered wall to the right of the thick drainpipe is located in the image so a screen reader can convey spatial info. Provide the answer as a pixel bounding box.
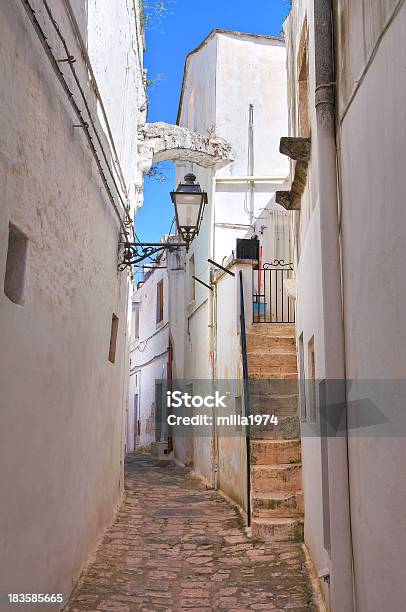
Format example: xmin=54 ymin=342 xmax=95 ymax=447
xmin=338 ymin=1 xmax=406 ymax=612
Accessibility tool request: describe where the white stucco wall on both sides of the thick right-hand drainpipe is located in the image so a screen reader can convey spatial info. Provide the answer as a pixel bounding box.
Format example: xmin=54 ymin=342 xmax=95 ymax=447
xmin=286 ymin=0 xmax=406 ymax=612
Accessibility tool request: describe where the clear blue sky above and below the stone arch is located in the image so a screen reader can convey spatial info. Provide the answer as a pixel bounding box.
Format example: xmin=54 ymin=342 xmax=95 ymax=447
xmin=136 ymin=0 xmax=290 ymax=242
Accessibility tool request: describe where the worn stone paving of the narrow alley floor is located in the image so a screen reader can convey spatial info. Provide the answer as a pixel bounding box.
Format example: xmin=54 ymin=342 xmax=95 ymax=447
xmin=66 ymin=454 xmax=316 ymax=612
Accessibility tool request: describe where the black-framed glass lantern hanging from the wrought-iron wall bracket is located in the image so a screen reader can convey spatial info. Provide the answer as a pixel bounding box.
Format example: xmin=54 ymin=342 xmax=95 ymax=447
xmin=171 ymin=174 xmax=207 ymax=251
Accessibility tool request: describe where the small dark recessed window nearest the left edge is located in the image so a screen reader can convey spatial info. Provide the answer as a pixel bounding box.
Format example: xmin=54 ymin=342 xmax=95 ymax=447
xmin=4 ymin=223 xmax=28 ymax=304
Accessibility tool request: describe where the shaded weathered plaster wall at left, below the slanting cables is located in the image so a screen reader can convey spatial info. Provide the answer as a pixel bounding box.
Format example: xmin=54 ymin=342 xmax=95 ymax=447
xmin=0 ymin=0 xmax=141 ymax=609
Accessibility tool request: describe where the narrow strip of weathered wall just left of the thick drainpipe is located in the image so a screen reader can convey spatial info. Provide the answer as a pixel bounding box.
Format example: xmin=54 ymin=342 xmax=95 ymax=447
xmin=284 ymin=0 xmax=336 ymax=601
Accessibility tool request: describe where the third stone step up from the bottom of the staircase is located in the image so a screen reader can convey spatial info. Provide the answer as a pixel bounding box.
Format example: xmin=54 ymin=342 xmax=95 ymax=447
xmin=251 ymin=463 xmax=302 ymax=495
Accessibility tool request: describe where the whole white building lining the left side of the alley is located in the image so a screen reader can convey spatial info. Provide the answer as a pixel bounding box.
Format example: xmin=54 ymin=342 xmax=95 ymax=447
xmin=0 ymin=0 xmax=144 ymax=609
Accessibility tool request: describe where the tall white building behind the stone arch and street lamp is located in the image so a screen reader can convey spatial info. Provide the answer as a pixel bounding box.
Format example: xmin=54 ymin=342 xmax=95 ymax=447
xmin=175 ymin=30 xmax=291 ymax=509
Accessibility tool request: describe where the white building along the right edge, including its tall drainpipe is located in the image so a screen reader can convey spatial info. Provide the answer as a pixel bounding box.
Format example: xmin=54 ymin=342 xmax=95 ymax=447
xmin=283 ymin=0 xmax=406 ymax=612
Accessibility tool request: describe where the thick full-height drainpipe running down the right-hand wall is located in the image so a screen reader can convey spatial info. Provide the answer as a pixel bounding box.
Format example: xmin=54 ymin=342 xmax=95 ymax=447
xmin=314 ymin=0 xmax=354 ymax=612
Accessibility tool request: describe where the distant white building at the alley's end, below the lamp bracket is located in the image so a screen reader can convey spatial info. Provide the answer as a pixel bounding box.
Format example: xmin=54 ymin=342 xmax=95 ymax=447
xmin=127 ymin=237 xmax=185 ymax=455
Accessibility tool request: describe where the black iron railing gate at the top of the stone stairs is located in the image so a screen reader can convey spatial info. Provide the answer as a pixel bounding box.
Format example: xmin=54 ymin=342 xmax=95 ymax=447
xmin=252 ymin=259 xmax=295 ymax=323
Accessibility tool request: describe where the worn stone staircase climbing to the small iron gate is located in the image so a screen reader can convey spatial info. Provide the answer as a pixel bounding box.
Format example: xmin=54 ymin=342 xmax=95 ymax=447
xmin=247 ymin=323 xmax=304 ymax=542
